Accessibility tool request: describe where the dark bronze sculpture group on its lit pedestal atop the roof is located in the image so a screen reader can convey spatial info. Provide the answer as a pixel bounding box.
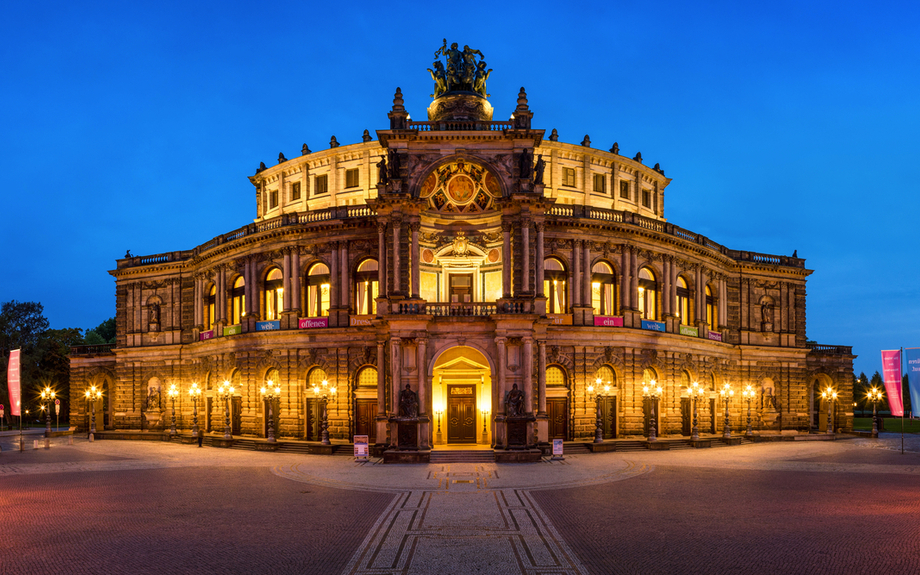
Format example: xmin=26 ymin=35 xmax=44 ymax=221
xmin=428 ymin=39 xmax=492 ymax=122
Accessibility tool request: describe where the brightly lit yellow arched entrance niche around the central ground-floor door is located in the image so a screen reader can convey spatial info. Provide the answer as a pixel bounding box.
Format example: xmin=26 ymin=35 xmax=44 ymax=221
xmin=432 ymin=346 xmax=492 ymax=445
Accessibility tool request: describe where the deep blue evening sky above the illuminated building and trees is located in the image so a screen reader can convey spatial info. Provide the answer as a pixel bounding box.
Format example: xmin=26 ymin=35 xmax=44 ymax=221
xmin=0 ymin=0 xmax=920 ymax=375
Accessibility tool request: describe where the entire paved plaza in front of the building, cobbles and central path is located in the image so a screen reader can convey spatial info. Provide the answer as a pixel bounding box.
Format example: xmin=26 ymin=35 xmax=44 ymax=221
xmin=0 ymin=434 xmax=920 ymax=575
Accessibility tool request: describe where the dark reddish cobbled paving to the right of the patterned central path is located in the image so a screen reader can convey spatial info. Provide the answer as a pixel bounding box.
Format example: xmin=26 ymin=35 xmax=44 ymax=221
xmin=533 ymin=460 xmax=920 ymax=575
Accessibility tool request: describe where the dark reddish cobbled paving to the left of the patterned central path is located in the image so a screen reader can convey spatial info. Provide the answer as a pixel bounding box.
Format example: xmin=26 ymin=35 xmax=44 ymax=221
xmin=0 ymin=468 xmax=393 ymax=575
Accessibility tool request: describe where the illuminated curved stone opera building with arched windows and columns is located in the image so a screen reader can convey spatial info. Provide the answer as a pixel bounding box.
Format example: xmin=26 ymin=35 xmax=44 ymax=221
xmin=71 ymin=68 xmax=854 ymax=449
